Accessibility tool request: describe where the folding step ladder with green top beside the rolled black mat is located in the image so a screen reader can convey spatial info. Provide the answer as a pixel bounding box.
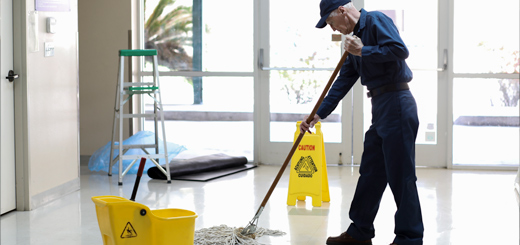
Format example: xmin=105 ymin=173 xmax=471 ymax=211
xmin=108 ymin=49 xmax=171 ymax=185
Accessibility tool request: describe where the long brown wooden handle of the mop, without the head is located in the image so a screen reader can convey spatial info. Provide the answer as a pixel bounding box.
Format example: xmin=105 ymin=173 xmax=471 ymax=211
xmin=257 ymin=51 xmax=348 ymax=210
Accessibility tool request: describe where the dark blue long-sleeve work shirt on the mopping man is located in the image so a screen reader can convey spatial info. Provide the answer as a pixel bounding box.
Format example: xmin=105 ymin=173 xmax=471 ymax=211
xmin=316 ymin=9 xmax=413 ymax=119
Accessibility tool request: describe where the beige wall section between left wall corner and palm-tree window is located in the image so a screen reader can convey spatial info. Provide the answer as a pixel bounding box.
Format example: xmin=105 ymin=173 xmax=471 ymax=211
xmin=79 ymin=0 xmax=135 ymax=155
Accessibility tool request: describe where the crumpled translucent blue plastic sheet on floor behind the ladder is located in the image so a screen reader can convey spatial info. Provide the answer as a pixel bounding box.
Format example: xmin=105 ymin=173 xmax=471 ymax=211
xmin=88 ymin=131 xmax=186 ymax=174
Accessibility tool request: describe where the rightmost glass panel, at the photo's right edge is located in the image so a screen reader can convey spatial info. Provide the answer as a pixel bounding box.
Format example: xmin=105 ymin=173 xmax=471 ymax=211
xmin=450 ymin=0 xmax=520 ymax=169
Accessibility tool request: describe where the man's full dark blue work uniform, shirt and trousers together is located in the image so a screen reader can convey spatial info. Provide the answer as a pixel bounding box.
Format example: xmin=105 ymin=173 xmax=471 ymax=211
xmin=317 ymin=9 xmax=424 ymax=245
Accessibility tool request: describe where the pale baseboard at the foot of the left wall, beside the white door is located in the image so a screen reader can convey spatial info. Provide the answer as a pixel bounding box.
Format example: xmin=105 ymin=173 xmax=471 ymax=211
xmin=30 ymin=178 xmax=80 ymax=210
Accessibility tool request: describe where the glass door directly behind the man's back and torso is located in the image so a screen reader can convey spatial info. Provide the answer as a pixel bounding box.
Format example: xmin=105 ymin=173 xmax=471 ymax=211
xmin=359 ymin=0 xmax=448 ymax=167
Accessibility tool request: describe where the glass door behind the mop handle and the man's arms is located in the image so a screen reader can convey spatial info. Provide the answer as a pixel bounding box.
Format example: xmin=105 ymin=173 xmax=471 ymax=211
xmin=257 ymin=0 xmax=351 ymax=164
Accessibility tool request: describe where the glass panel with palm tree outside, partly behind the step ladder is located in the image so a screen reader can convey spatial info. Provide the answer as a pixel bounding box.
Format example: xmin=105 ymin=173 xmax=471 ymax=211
xmin=134 ymin=0 xmax=255 ymax=161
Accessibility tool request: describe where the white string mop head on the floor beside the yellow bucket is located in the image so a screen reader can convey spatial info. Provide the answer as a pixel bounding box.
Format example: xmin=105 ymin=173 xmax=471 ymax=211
xmin=194 ymin=225 xmax=285 ymax=245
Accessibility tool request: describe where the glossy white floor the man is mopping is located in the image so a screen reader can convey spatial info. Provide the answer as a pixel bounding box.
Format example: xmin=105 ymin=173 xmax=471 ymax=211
xmin=1 ymin=162 xmax=519 ymax=245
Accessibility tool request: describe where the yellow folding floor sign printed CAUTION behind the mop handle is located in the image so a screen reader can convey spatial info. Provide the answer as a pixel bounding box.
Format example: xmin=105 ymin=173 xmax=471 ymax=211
xmin=287 ymin=121 xmax=330 ymax=207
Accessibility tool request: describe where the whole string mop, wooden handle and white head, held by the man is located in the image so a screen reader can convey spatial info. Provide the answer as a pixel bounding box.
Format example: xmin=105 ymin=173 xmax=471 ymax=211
xmin=195 ymin=51 xmax=348 ymax=245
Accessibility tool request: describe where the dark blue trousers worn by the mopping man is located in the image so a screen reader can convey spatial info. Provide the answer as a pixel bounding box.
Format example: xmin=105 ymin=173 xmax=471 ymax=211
xmin=347 ymin=90 xmax=424 ymax=245
